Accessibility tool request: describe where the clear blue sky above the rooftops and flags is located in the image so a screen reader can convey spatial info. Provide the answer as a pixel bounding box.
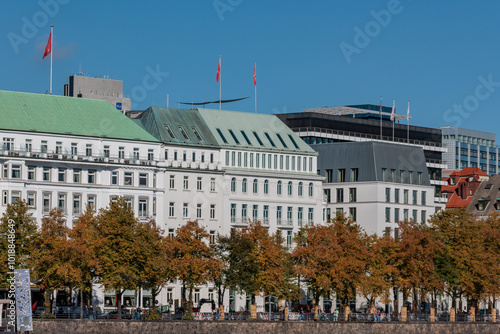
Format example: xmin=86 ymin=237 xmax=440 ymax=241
xmin=0 ymin=0 xmax=500 ymax=133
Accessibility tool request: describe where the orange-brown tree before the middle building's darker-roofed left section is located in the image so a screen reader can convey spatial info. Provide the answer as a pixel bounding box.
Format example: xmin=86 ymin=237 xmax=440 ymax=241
xmin=167 ymin=221 xmax=221 ymax=314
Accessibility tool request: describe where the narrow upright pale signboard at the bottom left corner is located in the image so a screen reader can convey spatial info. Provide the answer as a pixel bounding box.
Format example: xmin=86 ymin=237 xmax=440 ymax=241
xmin=14 ymin=269 xmax=33 ymax=331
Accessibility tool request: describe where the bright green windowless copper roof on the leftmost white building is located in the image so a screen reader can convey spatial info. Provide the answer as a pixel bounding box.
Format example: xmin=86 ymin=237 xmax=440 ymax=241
xmin=0 ymin=90 xmax=158 ymax=142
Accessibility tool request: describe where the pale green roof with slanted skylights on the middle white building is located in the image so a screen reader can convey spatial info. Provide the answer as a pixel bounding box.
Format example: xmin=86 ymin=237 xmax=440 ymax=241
xmin=136 ymin=107 xmax=316 ymax=155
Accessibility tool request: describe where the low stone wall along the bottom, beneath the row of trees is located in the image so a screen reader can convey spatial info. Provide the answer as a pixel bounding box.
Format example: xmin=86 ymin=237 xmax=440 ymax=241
xmin=33 ymin=320 xmax=500 ymax=334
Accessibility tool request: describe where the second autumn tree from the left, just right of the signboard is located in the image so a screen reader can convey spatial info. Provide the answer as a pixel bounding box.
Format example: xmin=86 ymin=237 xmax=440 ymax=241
xmin=31 ymin=209 xmax=79 ymax=312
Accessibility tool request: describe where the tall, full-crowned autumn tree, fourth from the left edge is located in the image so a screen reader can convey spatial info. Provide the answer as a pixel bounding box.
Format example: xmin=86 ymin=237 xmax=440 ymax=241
xmin=95 ymin=197 xmax=142 ymax=318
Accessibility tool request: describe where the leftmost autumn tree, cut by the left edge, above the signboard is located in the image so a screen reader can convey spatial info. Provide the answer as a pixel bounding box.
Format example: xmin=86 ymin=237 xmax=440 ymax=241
xmin=0 ymin=200 xmax=38 ymax=284
